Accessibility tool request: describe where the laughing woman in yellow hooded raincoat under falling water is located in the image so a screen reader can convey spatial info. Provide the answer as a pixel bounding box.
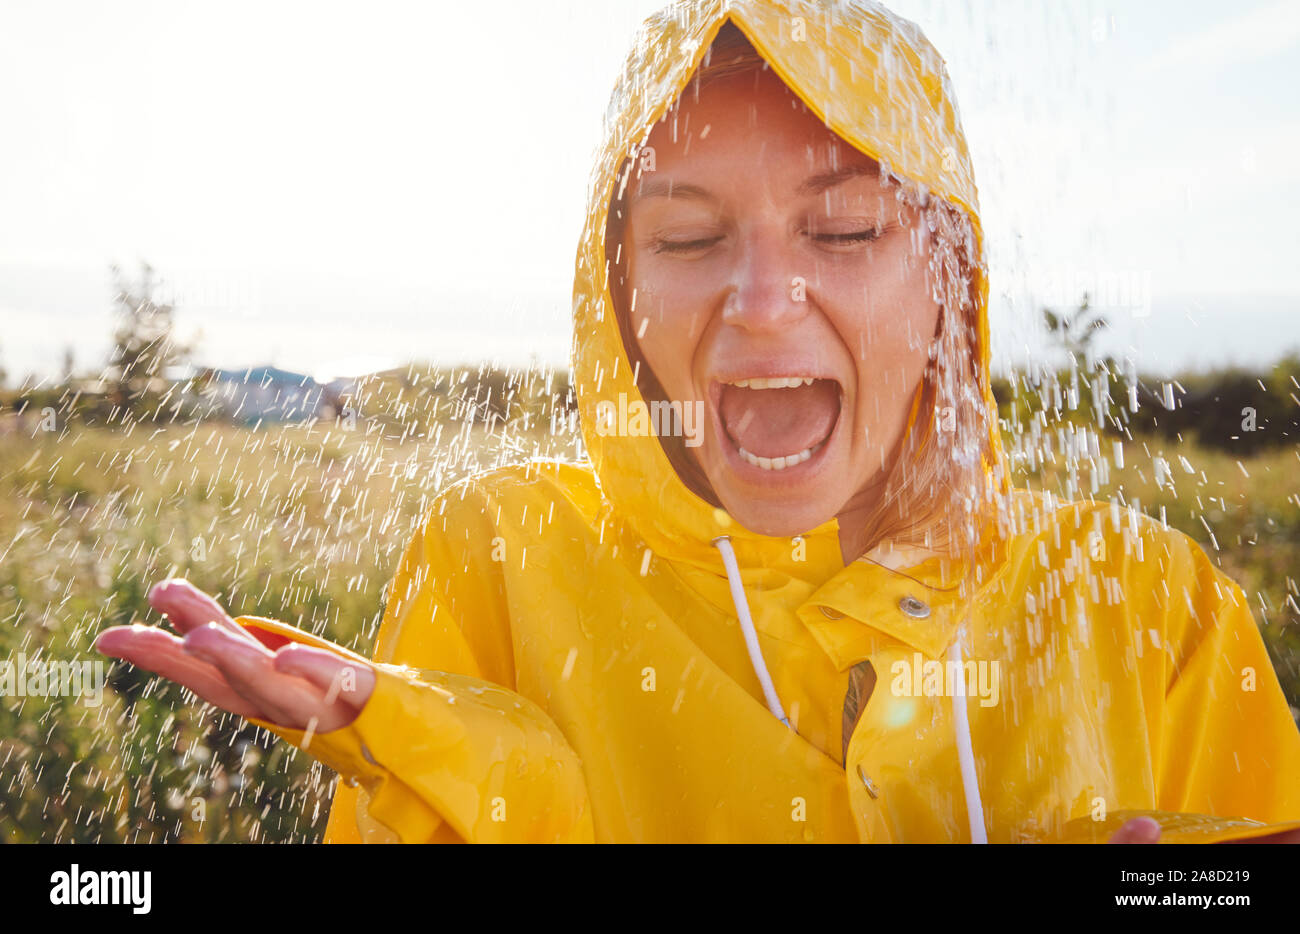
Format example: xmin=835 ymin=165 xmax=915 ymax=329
xmin=99 ymin=0 xmax=1300 ymax=843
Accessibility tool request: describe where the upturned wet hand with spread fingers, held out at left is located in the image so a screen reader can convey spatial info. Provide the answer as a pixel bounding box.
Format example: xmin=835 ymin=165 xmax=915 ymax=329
xmin=95 ymin=579 xmax=374 ymax=732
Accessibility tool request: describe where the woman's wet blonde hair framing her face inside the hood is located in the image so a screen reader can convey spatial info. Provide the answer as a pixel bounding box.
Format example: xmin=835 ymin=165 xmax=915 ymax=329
xmin=605 ymin=22 xmax=989 ymax=557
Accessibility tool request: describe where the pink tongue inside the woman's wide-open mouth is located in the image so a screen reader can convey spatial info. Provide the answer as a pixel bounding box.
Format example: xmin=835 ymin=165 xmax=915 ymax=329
xmin=719 ymin=380 xmax=840 ymax=458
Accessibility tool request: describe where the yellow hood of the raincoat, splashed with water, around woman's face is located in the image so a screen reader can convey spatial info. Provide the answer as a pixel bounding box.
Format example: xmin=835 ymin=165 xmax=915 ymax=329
xmin=573 ymin=0 xmax=1006 ymax=570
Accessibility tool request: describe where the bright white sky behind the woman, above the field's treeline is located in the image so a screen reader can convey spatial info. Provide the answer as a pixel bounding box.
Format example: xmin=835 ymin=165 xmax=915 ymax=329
xmin=0 ymin=0 xmax=1300 ymax=382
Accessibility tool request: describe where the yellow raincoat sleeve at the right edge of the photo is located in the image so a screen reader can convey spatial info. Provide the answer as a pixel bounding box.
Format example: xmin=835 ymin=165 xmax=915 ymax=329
xmin=1054 ymin=532 xmax=1300 ymax=843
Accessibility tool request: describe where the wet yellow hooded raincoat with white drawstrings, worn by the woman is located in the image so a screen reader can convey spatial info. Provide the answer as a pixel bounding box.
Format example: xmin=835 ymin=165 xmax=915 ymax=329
xmin=241 ymin=0 xmax=1300 ymax=843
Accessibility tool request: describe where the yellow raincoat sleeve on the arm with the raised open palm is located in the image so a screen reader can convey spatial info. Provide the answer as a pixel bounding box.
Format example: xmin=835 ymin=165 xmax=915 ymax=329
xmin=238 ymin=489 xmax=593 ymax=843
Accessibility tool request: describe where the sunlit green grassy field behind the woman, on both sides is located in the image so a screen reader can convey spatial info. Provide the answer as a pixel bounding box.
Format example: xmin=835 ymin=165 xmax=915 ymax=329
xmin=0 ymin=390 xmax=1300 ymax=842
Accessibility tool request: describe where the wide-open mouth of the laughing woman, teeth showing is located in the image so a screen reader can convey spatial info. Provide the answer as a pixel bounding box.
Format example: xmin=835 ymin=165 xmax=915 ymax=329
xmin=718 ymin=375 xmax=842 ymax=471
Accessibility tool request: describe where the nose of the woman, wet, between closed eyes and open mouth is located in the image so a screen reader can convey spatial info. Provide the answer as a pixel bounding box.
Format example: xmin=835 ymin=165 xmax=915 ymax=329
xmin=723 ymin=230 xmax=809 ymax=333
